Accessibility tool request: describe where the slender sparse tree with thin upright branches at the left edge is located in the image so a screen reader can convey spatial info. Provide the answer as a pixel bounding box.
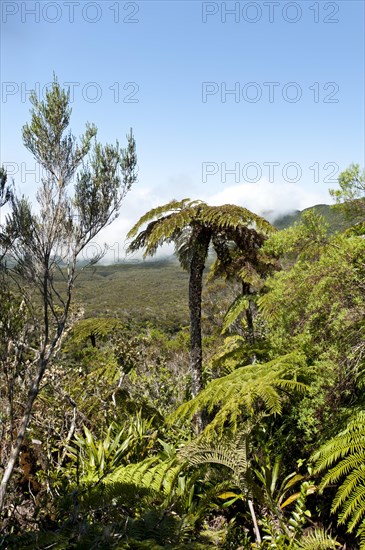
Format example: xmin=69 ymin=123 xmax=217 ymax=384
xmin=0 ymin=78 xmax=136 ymax=511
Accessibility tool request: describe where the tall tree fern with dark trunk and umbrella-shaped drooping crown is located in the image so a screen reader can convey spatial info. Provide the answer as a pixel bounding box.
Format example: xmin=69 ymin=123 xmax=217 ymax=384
xmin=128 ymin=199 xmax=273 ymax=418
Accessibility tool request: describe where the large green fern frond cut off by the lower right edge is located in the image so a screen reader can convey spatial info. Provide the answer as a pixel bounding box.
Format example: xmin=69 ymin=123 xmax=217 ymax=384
xmin=312 ymin=411 xmax=365 ymax=549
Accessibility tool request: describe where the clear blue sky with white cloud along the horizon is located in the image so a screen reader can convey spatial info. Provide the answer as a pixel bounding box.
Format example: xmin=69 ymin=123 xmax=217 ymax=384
xmin=0 ymin=0 xmax=365 ymax=258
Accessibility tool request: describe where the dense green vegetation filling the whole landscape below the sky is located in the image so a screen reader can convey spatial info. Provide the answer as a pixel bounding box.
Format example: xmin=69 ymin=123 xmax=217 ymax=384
xmin=0 ymin=82 xmax=365 ymax=550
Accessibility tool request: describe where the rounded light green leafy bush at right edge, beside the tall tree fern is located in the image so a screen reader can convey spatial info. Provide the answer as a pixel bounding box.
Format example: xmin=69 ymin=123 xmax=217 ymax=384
xmin=259 ymin=231 xmax=365 ymax=355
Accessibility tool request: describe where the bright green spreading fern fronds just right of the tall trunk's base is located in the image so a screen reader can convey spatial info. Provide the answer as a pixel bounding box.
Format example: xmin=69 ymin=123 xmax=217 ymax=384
xmin=169 ymin=353 xmax=306 ymax=440
